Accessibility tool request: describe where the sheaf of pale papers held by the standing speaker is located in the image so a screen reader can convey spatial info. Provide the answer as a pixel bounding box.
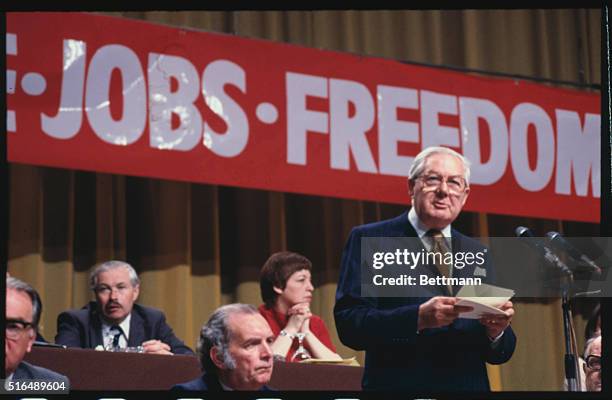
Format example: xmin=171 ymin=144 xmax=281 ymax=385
xmin=455 ymin=283 xmax=514 ymax=319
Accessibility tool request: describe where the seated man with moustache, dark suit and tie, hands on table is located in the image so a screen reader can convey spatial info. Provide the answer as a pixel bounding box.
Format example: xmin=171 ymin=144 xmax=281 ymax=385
xmin=55 ymin=261 xmax=193 ymax=354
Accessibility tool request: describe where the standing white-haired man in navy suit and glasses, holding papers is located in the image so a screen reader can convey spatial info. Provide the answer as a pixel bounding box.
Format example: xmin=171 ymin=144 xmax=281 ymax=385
xmin=334 ymin=147 xmax=516 ymax=392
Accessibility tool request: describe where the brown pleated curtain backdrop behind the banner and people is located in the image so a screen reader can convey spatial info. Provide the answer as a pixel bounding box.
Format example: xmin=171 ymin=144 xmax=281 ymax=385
xmin=9 ymin=9 xmax=601 ymax=390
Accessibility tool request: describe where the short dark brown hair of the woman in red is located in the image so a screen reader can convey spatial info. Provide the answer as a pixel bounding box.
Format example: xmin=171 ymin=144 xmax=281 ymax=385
xmin=259 ymin=251 xmax=312 ymax=308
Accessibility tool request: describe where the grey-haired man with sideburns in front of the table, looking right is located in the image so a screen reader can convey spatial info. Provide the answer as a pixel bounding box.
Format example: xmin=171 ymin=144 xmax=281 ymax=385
xmin=172 ymin=303 xmax=274 ymax=392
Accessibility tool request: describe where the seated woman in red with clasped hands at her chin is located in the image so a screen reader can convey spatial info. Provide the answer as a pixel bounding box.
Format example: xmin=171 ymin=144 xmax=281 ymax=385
xmin=259 ymin=251 xmax=341 ymax=361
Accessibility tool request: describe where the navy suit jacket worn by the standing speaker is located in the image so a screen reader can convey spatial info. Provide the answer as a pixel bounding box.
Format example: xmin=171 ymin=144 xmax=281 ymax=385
xmin=334 ymin=212 xmax=516 ymax=392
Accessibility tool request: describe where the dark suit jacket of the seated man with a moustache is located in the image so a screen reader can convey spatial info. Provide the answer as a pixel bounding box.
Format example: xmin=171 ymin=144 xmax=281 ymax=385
xmin=55 ymin=301 xmax=193 ymax=354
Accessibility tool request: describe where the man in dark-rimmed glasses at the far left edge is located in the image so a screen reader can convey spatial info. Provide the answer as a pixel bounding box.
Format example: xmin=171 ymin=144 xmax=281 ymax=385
xmin=4 ymin=277 xmax=70 ymax=384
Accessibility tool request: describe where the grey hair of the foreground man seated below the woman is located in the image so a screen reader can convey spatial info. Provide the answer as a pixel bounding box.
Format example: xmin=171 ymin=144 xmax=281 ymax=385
xmin=197 ymin=303 xmax=259 ymax=373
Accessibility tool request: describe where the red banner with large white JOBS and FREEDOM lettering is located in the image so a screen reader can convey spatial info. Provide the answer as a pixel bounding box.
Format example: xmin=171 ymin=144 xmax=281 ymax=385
xmin=6 ymin=13 xmax=601 ymax=222
